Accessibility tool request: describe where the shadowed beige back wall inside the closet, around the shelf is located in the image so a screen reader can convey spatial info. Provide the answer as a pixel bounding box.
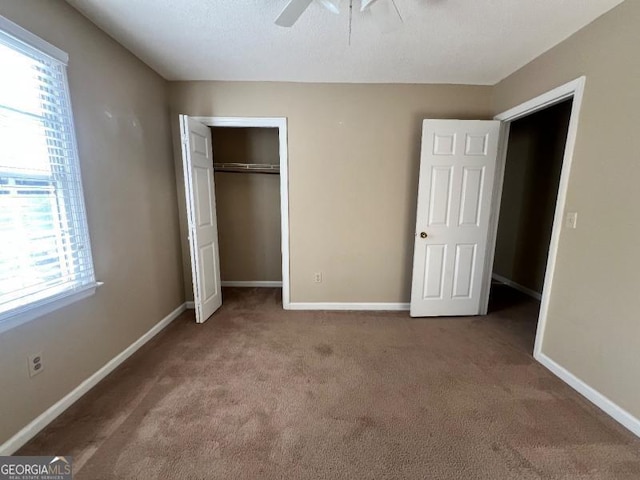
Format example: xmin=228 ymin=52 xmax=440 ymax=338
xmin=211 ymin=127 xmax=282 ymax=282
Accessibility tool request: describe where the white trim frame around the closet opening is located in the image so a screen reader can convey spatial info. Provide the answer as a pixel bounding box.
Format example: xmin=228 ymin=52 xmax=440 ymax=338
xmin=190 ymin=115 xmax=291 ymax=310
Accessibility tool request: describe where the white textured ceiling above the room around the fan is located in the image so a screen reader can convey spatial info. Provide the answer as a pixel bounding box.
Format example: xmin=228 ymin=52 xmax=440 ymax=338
xmin=67 ymin=0 xmax=620 ymax=85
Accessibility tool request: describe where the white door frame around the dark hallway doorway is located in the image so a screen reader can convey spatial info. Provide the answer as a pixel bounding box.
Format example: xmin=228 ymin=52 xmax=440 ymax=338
xmin=480 ymin=76 xmax=586 ymax=359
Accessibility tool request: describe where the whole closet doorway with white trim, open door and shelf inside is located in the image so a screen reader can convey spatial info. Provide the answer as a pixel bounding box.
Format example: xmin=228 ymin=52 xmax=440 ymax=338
xmin=180 ymin=115 xmax=290 ymax=323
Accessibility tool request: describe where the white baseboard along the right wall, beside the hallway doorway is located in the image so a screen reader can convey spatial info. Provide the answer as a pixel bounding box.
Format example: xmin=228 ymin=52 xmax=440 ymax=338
xmin=534 ymin=353 xmax=640 ymax=437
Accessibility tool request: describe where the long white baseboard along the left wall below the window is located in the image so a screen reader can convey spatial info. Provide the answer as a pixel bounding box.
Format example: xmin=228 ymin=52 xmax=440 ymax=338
xmin=0 ymin=304 xmax=186 ymax=456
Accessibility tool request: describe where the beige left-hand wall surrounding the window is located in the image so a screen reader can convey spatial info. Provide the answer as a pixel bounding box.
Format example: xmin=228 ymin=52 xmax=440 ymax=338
xmin=0 ymin=0 xmax=184 ymax=444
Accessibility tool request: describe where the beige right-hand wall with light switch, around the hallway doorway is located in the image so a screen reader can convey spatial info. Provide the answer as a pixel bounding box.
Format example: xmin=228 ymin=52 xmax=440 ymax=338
xmin=494 ymin=0 xmax=640 ymax=418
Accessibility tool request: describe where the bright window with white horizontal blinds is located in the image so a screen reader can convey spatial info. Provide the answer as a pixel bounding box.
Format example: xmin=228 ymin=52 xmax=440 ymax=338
xmin=0 ymin=17 xmax=96 ymax=325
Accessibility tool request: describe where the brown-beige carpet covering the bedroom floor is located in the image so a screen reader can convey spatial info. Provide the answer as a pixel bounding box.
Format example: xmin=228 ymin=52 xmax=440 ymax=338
xmin=19 ymin=288 xmax=640 ymax=480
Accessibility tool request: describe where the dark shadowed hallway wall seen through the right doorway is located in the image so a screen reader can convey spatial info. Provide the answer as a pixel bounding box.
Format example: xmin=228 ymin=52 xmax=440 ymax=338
xmin=493 ymin=100 xmax=572 ymax=293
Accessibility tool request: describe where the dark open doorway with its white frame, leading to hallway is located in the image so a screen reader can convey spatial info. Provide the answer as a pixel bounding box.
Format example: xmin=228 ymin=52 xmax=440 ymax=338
xmin=481 ymin=77 xmax=585 ymax=359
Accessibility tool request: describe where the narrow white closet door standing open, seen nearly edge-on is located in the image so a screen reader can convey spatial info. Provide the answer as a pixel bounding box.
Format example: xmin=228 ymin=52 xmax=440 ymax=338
xmin=180 ymin=115 xmax=222 ymax=323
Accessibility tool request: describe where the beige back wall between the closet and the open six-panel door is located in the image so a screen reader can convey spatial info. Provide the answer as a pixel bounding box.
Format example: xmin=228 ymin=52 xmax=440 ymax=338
xmin=170 ymin=82 xmax=491 ymax=302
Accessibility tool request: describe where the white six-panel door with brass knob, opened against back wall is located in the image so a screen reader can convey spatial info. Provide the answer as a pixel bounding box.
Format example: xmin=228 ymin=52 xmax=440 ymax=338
xmin=410 ymin=120 xmax=500 ymax=317
